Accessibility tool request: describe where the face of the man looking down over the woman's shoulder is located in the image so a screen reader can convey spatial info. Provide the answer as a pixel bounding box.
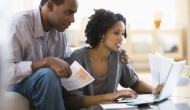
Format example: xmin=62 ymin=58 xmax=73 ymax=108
xmin=48 ymin=0 xmax=78 ymax=32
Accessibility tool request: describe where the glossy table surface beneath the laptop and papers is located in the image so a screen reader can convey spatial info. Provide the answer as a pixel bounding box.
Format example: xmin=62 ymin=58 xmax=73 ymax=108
xmin=81 ymin=86 xmax=190 ymax=110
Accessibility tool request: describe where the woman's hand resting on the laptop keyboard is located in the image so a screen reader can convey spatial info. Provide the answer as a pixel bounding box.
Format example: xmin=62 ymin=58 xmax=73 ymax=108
xmin=108 ymin=89 xmax=138 ymax=101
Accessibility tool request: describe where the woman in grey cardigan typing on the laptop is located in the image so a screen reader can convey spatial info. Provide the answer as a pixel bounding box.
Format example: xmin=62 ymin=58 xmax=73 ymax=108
xmin=65 ymin=9 xmax=162 ymax=109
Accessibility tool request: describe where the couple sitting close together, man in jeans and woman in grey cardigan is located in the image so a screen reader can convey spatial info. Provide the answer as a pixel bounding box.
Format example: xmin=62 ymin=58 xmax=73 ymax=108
xmin=7 ymin=0 xmax=162 ymax=110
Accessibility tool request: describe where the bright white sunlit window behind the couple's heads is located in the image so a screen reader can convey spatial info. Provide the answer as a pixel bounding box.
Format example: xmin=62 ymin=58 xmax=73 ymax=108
xmin=2 ymin=0 xmax=175 ymax=30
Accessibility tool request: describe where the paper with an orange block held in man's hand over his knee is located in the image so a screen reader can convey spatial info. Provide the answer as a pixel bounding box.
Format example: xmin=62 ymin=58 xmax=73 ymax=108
xmin=60 ymin=61 xmax=94 ymax=91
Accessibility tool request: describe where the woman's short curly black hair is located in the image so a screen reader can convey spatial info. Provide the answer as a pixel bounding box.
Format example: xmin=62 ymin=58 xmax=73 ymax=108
xmin=85 ymin=9 xmax=127 ymax=48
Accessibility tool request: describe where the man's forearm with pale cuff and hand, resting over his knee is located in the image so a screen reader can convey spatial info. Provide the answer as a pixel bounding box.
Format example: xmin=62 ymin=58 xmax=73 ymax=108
xmin=5 ymin=53 xmax=71 ymax=85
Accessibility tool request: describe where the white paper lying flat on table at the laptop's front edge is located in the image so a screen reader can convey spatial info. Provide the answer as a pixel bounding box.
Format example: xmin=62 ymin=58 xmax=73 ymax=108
xmin=100 ymin=104 xmax=137 ymax=110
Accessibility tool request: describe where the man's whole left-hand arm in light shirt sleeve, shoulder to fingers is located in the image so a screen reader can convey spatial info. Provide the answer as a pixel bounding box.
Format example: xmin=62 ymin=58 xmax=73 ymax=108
xmin=5 ymin=21 xmax=71 ymax=85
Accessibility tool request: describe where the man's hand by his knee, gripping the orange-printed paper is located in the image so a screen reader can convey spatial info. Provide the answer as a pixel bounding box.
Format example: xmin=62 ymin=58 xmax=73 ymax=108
xmin=48 ymin=57 xmax=72 ymax=78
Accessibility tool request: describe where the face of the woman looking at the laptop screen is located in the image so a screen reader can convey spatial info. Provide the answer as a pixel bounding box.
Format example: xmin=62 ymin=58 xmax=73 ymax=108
xmin=102 ymin=21 xmax=125 ymax=51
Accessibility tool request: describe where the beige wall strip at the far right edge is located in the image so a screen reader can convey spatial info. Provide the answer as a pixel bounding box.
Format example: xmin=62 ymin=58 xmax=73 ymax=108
xmin=175 ymin=0 xmax=190 ymax=65
